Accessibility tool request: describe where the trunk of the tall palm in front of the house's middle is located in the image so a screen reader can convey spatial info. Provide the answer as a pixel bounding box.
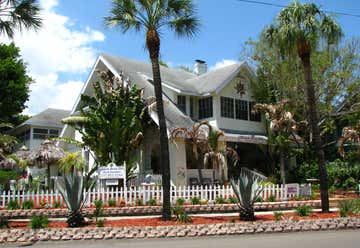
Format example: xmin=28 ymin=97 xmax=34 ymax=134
xmin=146 ymin=30 xmax=171 ymax=221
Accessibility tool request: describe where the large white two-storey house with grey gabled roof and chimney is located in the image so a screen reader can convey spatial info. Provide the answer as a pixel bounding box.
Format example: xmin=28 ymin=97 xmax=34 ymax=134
xmin=62 ymin=54 xmax=267 ymax=185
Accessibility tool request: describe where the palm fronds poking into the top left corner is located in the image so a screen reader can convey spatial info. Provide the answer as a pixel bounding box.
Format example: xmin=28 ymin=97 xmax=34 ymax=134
xmin=0 ymin=0 xmax=42 ymax=38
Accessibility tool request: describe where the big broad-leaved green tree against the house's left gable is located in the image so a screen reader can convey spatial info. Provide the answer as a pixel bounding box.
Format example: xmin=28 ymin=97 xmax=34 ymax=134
xmin=63 ymin=71 xmax=150 ymax=181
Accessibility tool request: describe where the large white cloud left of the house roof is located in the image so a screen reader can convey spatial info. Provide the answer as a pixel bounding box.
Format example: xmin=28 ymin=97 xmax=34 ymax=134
xmin=0 ymin=0 xmax=105 ymax=114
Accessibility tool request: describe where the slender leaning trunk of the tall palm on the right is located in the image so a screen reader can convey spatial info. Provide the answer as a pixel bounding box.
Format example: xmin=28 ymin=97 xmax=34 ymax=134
xmin=300 ymin=53 xmax=329 ymax=213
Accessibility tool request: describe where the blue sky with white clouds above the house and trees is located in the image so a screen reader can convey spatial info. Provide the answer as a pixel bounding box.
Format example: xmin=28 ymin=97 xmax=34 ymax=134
xmin=0 ymin=0 xmax=360 ymax=114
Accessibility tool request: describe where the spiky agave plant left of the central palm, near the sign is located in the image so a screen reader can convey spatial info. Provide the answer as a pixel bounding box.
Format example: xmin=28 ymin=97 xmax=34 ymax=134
xmin=56 ymin=173 xmax=88 ymax=227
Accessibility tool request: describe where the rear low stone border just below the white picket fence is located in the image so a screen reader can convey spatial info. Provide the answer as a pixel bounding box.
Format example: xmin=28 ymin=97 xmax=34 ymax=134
xmin=0 ymin=201 xmax=320 ymax=219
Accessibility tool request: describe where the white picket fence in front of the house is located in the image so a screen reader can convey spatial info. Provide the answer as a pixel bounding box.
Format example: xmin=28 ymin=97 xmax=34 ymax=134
xmin=0 ymin=185 xmax=299 ymax=208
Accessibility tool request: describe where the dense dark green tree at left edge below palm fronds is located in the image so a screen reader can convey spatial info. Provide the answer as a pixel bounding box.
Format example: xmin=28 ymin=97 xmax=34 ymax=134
xmin=0 ymin=43 xmax=32 ymax=124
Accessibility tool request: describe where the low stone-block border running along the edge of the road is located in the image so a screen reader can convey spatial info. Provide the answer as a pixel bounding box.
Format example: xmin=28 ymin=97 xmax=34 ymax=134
xmin=0 ymin=217 xmax=360 ymax=243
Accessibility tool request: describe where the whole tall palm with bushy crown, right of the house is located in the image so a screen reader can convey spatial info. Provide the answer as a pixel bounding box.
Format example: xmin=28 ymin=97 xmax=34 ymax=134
xmin=264 ymin=1 xmax=342 ymax=212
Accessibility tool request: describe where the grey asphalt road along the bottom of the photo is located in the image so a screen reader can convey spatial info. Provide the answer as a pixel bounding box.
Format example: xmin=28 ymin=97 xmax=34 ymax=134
xmin=1 ymin=230 xmax=360 ymax=248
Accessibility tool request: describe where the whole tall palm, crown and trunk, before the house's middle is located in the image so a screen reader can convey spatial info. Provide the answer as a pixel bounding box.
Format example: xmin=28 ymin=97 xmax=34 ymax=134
xmin=105 ymin=0 xmax=199 ymax=220
